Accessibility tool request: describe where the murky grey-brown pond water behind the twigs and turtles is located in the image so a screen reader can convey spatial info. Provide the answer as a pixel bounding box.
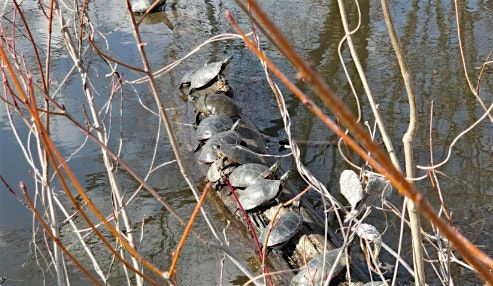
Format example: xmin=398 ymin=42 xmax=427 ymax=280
xmin=0 ymin=0 xmax=493 ymax=285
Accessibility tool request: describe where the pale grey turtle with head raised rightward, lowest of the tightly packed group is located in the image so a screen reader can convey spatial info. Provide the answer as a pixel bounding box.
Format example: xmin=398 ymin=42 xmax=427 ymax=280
xmin=236 ymin=171 xmax=291 ymax=210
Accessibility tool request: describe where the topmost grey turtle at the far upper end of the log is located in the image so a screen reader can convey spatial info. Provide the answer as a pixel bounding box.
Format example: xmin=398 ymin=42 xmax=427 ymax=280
xmin=180 ymin=57 xmax=231 ymax=93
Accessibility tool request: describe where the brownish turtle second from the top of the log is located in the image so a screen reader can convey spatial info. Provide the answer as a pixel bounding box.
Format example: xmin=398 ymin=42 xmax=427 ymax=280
xmin=195 ymin=93 xmax=241 ymax=119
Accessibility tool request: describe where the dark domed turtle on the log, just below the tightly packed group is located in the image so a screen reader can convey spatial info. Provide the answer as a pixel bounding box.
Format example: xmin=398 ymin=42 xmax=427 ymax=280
xmin=260 ymin=212 xmax=303 ymax=247
